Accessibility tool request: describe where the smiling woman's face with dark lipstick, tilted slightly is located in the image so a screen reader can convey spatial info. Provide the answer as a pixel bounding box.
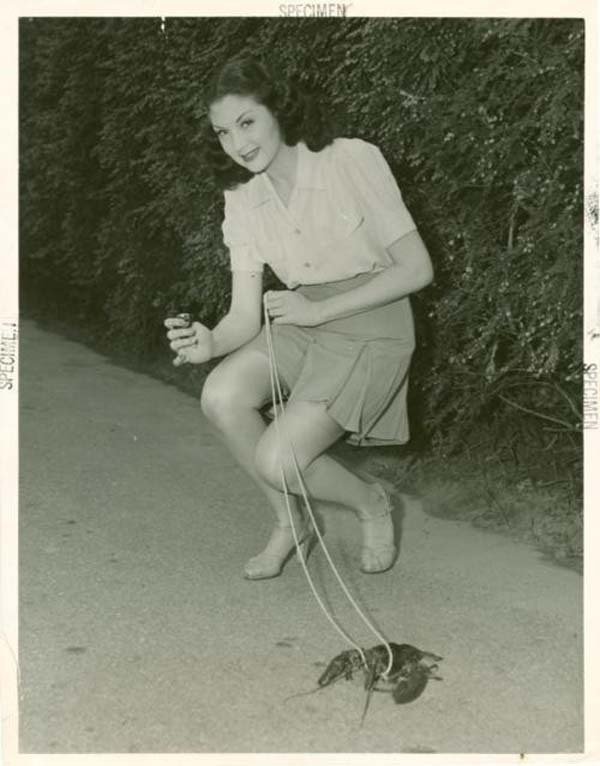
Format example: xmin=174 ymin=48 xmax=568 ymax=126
xmin=209 ymin=95 xmax=283 ymax=173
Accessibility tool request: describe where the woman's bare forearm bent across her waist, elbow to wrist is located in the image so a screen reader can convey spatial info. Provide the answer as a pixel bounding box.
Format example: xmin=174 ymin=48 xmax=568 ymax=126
xmin=318 ymin=235 xmax=433 ymax=322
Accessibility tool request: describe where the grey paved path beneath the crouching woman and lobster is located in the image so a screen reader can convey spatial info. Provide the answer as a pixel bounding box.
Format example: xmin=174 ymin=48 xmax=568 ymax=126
xmin=20 ymin=322 xmax=583 ymax=753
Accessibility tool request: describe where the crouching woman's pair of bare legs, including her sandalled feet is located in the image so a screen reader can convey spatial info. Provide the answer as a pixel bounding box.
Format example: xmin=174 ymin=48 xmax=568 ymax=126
xmin=202 ymin=348 xmax=393 ymax=577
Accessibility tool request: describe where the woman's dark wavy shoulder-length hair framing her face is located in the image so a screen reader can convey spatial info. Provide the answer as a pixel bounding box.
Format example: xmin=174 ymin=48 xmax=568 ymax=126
xmin=202 ymin=54 xmax=334 ymax=189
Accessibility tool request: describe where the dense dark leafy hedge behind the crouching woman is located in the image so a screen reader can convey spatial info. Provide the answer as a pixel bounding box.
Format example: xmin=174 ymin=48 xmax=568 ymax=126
xmin=20 ymin=18 xmax=584 ymax=456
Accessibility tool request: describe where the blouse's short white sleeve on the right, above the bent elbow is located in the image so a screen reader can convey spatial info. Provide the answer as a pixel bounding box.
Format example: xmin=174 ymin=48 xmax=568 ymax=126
xmin=336 ymin=138 xmax=417 ymax=247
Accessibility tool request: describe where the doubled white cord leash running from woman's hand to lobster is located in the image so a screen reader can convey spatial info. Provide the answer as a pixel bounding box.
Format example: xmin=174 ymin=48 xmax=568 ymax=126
xmin=263 ymin=297 xmax=394 ymax=678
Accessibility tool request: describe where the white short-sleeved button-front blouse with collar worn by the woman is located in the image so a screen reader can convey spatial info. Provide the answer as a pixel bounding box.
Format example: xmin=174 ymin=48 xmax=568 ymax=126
xmin=222 ymin=138 xmax=416 ymax=289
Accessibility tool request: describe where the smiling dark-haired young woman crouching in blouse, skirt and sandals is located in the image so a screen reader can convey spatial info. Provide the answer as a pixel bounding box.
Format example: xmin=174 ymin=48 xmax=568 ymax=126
xmin=165 ymin=56 xmax=432 ymax=579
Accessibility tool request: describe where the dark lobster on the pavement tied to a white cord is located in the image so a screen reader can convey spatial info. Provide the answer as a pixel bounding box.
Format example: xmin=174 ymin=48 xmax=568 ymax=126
xmin=294 ymin=642 xmax=442 ymax=724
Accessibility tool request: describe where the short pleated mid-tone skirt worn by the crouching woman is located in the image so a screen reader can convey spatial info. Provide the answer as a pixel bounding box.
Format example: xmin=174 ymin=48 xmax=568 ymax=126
xmin=248 ymin=274 xmax=415 ymax=446
